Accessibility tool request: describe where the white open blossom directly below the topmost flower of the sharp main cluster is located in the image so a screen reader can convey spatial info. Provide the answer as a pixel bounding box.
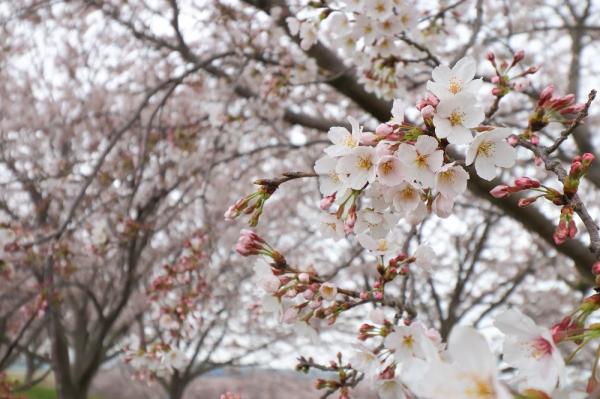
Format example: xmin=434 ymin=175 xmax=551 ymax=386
xmin=433 ymin=94 xmax=485 ymax=144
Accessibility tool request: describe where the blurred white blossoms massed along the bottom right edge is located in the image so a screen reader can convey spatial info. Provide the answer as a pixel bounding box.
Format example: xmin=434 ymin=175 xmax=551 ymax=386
xmin=351 ymin=309 xmax=585 ymax=399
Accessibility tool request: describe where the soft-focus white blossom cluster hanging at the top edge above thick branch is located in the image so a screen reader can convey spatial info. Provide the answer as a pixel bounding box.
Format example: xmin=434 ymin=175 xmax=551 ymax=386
xmin=286 ymin=0 xmax=437 ymax=98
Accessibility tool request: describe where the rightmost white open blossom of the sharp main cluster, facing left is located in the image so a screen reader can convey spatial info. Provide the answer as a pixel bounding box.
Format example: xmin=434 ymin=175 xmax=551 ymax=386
xmin=465 ymin=128 xmax=516 ymax=180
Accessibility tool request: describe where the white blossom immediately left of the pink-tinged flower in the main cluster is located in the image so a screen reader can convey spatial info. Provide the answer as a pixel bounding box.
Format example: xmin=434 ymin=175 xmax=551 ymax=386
xmin=335 ymin=146 xmax=377 ymax=190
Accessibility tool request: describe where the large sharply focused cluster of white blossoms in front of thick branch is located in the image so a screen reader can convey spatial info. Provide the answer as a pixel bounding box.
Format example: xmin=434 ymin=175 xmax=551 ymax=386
xmin=315 ymin=58 xmax=516 ymax=255
